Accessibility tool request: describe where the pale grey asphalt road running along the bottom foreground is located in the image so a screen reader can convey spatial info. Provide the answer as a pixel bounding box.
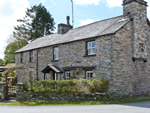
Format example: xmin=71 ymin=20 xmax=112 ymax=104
xmin=0 ymin=101 xmax=150 ymax=113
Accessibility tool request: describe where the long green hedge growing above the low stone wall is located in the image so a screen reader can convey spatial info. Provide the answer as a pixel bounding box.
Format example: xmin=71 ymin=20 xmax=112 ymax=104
xmin=32 ymin=79 xmax=108 ymax=94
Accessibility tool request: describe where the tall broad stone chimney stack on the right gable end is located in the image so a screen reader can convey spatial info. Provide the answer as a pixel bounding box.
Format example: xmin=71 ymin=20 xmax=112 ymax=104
xmin=123 ymin=0 xmax=148 ymax=59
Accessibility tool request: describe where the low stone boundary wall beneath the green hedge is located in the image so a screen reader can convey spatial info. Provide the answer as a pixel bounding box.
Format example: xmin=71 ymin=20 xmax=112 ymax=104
xmin=17 ymin=92 xmax=107 ymax=101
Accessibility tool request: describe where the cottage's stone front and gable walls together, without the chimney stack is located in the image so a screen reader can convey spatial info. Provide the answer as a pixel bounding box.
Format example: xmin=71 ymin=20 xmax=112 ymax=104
xmin=16 ymin=21 xmax=150 ymax=95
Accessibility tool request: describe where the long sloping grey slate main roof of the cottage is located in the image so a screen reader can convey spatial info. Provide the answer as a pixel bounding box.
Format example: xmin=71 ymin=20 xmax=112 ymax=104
xmin=15 ymin=15 xmax=129 ymax=53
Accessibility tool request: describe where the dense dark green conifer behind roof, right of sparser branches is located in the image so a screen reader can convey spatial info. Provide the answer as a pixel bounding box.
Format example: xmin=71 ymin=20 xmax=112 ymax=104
xmin=31 ymin=4 xmax=55 ymax=40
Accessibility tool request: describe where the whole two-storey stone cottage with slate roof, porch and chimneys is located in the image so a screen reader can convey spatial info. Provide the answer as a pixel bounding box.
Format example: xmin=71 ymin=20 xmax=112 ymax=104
xmin=15 ymin=0 xmax=150 ymax=95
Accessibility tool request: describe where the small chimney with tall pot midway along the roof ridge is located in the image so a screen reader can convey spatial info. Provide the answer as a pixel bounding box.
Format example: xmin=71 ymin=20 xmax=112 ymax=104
xmin=58 ymin=16 xmax=73 ymax=34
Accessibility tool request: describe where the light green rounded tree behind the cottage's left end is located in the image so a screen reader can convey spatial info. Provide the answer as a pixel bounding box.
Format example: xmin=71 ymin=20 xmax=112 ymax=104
xmin=4 ymin=39 xmax=28 ymax=65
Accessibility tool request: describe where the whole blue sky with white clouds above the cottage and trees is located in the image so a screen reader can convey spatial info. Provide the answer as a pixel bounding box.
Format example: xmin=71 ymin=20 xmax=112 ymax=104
xmin=0 ymin=0 xmax=150 ymax=59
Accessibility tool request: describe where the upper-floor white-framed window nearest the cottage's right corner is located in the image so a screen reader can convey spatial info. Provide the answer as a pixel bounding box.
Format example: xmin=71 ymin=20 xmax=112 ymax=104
xmin=87 ymin=41 xmax=95 ymax=55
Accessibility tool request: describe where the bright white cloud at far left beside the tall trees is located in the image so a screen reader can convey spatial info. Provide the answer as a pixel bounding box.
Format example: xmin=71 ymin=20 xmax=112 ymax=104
xmin=0 ymin=0 xmax=29 ymax=58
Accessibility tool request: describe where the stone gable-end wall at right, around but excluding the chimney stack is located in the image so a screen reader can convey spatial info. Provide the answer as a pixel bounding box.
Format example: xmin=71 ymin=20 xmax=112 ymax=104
xmin=109 ymin=21 xmax=150 ymax=96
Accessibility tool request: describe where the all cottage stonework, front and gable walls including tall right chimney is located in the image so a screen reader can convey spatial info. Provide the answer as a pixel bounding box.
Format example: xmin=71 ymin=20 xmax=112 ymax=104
xmin=16 ymin=0 xmax=150 ymax=95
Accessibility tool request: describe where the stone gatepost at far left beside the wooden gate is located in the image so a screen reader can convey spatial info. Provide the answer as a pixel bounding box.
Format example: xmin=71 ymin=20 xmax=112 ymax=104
xmin=0 ymin=82 xmax=8 ymax=101
